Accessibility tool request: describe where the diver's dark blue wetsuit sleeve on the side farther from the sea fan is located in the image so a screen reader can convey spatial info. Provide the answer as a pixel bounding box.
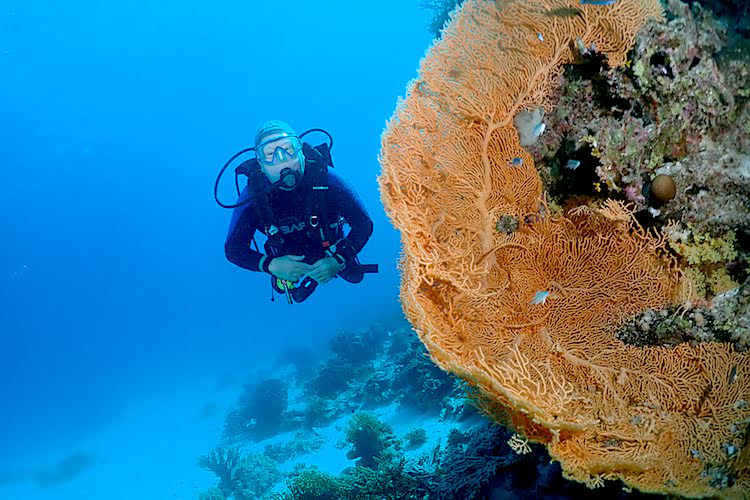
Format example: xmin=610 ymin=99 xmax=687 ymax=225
xmin=224 ymin=191 xmax=270 ymax=272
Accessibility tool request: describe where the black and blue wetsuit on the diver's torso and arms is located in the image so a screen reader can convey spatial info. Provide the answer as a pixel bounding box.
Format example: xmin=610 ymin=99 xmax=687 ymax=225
xmin=224 ymin=169 xmax=372 ymax=282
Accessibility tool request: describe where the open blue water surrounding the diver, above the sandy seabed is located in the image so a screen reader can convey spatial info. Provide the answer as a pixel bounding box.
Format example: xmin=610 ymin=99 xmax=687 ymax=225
xmin=0 ymin=0 xmax=431 ymax=484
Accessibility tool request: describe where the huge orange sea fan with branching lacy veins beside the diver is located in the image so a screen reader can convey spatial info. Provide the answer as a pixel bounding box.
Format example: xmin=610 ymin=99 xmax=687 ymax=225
xmin=380 ymin=0 xmax=750 ymax=497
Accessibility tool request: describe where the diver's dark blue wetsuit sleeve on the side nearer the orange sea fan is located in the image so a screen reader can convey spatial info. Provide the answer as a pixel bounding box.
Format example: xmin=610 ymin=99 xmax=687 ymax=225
xmin=329 ymin=171 xmax=373 ymax=263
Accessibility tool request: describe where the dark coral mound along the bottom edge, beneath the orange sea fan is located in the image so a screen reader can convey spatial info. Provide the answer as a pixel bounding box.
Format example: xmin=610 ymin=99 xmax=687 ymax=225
xmin=274 ymin=423 xmax=648 ymax=500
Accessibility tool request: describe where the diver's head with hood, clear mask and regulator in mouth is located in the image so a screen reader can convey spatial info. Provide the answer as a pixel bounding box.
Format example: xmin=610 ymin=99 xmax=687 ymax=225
xmin=255 ymin=120 xmax=305 ymax=191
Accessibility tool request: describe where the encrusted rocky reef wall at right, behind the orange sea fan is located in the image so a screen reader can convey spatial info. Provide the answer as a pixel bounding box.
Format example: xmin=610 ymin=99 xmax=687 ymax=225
xmin=530 ymin=0 xmax=750 ymax=350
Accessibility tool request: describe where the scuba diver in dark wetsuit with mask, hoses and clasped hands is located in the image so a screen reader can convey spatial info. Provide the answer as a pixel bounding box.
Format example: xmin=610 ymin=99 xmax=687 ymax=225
xmin=219 ymin=120 xmax=377 ymax=304
